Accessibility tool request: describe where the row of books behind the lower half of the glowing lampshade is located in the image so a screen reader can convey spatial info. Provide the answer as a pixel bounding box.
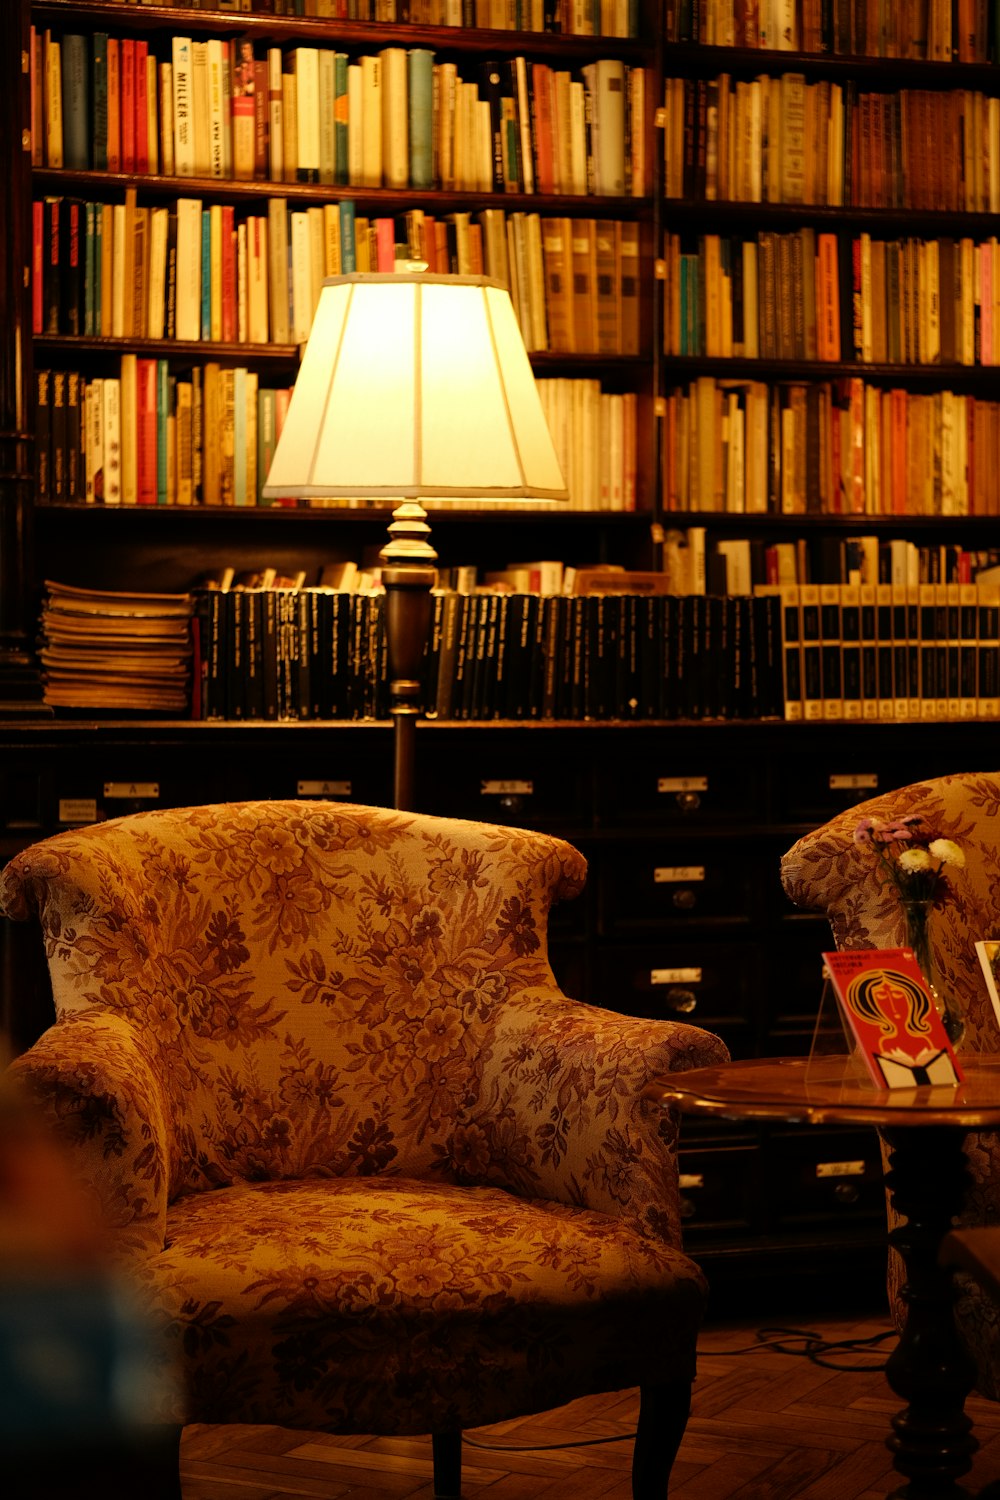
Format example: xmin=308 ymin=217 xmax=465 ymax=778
xmin=34 ymin=363 xmax=636 ymax=510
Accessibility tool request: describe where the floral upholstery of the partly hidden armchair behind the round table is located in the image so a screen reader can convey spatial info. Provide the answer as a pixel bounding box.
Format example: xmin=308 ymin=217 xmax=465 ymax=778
xmin=781 ymin=773 xmax=1000 ymax=1400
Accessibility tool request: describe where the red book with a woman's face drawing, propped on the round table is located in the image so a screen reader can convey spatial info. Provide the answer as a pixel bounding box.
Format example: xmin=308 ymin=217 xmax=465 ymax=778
xmin=823 ymin=948 xmax=963 ymax=1089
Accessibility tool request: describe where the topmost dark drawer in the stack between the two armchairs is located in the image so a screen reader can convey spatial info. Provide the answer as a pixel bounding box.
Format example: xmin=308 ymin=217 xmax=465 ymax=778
xmin=601 ymin=756 xmax=763 ymax=828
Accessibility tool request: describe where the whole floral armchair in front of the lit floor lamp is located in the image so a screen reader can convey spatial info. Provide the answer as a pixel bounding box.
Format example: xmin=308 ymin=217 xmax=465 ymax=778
xmin=0 ymin=801 xmax=726 ymax=1497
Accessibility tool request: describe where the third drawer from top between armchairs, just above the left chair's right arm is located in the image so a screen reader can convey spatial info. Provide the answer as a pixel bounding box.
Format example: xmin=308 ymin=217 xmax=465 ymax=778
xmin=591 ymin=939 xmax=760 ymax=1058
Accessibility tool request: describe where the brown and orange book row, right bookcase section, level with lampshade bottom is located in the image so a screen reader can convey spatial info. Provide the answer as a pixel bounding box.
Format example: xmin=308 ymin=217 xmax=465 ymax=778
xmin=663 ymin=375 xmax=1000 ymax=516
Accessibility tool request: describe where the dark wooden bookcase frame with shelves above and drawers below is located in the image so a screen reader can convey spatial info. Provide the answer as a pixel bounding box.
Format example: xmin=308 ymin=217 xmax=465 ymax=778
xmin=0 ymin=0 xmax=1000 ymax=1296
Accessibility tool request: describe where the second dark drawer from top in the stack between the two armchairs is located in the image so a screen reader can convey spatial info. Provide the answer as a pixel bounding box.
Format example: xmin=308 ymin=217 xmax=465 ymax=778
xmin=589 ymin=839 xmax=763 ymax=935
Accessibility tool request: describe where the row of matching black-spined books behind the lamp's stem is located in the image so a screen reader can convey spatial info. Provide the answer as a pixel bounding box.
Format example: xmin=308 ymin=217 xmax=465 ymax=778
xmin=195 ymin=588 xmax=783 ymax=720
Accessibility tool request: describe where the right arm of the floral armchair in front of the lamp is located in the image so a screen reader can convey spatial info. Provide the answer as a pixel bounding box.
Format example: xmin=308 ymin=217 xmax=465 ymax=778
xmin=451 ymin=989 xmax=729 ymax=1247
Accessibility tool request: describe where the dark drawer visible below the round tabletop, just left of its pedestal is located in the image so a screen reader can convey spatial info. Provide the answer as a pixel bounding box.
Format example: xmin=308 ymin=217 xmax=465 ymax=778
xmin=766 ymin=1127 xmax=885 ymax=1230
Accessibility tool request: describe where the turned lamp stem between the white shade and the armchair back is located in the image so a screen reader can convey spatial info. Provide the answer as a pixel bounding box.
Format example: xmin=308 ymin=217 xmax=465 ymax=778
xmin=379 ymin=500 xmax=438 ymax=812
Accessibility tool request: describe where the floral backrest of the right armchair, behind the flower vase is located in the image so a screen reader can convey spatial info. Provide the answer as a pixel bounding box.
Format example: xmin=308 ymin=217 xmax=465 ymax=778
xmin=781 ymin=771 xmax=1000 ymax=1050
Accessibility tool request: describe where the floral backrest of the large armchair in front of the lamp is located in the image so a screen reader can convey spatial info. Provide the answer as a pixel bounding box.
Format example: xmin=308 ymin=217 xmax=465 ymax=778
xmin=0 ymin=801 xmax=586 ymax=1199
